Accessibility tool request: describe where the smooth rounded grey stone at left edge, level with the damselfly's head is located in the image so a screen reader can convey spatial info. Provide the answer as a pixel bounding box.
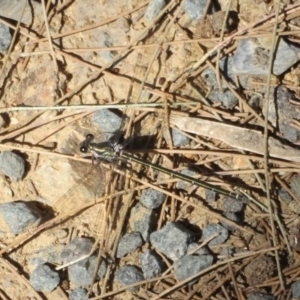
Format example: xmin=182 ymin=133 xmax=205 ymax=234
xmin=0 ymin=151 xmax=25 ymax=181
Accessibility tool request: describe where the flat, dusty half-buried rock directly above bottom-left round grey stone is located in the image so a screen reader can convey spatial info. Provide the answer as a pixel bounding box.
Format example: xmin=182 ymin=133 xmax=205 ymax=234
xmin=28 ymin=244 xmax=65 ymax=265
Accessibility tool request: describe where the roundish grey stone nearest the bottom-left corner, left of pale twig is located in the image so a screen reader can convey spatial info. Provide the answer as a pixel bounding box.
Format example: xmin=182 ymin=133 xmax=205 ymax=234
xmin=30 ymin=265 xmax=60 ymax=292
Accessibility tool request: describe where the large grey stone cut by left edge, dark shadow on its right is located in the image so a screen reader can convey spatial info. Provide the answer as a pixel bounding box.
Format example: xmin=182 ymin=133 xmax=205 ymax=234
xmin=0 ymin=201 xmax=41 ymax=234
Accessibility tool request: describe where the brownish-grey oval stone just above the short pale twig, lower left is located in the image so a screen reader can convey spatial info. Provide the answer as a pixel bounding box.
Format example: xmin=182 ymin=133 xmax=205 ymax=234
xmin=60 ymin=237 xmax=93 ymax=264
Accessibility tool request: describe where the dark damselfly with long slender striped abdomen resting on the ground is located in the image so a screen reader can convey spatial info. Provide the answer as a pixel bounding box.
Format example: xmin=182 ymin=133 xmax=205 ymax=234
xmin=80 ymin=134 xmax=247 ymax=201
